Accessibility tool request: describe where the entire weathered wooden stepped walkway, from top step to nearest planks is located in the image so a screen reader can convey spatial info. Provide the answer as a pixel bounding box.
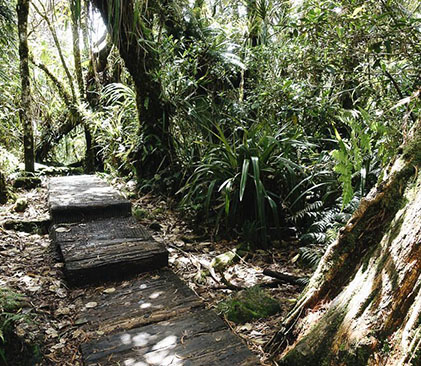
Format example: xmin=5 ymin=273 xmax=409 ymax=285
xmin=49 ymin=175 xmax=260 ymax=366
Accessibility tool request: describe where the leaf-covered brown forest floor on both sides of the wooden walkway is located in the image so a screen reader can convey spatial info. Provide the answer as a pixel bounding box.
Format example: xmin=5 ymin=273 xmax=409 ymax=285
xmin=0 ymin=176 xmax=309 ymax=366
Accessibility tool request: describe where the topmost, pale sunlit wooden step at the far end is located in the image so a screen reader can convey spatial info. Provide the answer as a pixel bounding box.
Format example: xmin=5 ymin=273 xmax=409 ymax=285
xmin=49 ymin=175 xmax=131 ymax=223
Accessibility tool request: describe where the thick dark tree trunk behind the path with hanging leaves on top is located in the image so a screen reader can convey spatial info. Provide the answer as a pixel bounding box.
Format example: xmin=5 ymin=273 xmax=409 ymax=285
xmin=92 ymin=0 xmax=173 ymax=177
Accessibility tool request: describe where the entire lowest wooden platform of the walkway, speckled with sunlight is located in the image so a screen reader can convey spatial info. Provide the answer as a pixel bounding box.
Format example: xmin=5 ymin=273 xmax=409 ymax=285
xmin=81 ymin=271 xmax=259 ymax=366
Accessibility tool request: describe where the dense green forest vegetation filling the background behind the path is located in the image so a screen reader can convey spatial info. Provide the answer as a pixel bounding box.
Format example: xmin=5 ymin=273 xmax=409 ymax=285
xmin=0 ymin=0 xmax=421 ymax=364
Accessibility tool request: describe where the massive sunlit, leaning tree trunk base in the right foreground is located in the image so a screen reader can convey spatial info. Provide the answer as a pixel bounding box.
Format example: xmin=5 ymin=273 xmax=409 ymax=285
xmin=267 ymin=127 xmax=421 ymax=366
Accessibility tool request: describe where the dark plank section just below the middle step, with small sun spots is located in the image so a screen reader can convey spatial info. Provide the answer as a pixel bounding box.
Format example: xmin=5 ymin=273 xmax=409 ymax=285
xmin=80 ymin=270 xmax=203 ymax=335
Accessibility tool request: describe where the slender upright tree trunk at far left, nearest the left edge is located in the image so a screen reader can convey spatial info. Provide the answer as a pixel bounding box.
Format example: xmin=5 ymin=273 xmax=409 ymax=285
xmin=16 ymin=0 xmax=35 ymax=172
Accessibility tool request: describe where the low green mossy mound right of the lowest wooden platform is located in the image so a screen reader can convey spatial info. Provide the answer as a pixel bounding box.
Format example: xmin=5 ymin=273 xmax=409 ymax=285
xmin=218 ymin=286 xmax=280 ymax=323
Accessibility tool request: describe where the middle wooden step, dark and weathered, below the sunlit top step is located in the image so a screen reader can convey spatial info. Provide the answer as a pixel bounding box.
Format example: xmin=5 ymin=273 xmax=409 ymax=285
xmin=50 ymin=217 xmax=168 ymax=285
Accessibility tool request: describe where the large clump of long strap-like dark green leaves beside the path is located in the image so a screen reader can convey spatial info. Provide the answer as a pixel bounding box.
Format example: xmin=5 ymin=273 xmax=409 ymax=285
xmin=179 ymin=124 xmax=312 ymax=247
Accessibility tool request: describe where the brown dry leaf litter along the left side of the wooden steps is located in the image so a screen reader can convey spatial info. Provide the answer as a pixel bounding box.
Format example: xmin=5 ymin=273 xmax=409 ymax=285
xmin=0 ymin=184 xmax=84 ymax=366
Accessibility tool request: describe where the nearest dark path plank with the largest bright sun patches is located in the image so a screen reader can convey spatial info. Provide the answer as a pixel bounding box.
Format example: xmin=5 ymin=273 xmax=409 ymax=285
xmin=82 ymin=310 xmax=258 ymax=366
